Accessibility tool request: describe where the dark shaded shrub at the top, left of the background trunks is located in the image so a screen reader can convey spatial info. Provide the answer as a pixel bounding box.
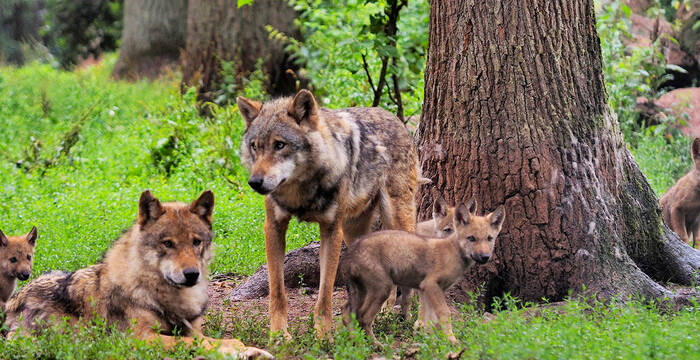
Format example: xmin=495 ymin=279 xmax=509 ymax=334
xmin=43 ymin=0 xmax=124 ymax=68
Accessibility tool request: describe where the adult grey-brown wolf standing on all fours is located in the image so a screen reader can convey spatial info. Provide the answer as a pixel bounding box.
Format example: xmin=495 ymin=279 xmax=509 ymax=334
xmin=238 ymin=90 xmax=418 ymax=339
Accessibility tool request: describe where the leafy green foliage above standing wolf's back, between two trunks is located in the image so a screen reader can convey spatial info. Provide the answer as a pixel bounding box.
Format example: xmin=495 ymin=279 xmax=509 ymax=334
xmin=272 ymin=0 xmax=428 ymax=116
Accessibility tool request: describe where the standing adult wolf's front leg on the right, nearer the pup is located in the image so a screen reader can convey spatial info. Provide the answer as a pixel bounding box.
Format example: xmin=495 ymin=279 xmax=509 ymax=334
xmin=314 ymin=222 xmax=343 ymax=337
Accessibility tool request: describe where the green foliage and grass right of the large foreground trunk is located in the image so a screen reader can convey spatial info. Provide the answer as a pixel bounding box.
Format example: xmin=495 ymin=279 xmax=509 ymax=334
xmin=598 ymin=1 xmax=692 ymax=196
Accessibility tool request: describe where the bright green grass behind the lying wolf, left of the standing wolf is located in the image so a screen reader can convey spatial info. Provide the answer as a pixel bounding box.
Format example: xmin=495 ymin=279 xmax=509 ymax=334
xmin=0 ymin=57 xmax=317 ymax=276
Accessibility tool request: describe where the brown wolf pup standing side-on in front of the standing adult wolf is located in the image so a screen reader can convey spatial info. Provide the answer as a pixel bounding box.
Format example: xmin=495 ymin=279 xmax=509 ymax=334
xmin=341 ymin=198 xmax=505 ymax=345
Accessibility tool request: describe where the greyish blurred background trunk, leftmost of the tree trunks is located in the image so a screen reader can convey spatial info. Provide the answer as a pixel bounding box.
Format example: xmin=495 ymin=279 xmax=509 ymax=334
xmin=112 ymin=0 xmax=186 ymax=79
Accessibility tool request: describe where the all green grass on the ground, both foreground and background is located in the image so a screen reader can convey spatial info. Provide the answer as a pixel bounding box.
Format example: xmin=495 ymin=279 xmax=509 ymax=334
xmin=0 ymin=56 xmax=700 ymax=359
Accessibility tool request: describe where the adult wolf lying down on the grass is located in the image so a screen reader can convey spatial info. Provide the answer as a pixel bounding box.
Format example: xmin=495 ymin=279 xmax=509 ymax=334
xmin=6 ymin=191 xmax=271 ymax=357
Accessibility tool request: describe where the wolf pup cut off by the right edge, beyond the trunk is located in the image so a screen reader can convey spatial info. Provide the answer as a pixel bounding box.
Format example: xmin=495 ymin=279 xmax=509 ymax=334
xmin=659 ymin=138 xmax=700 ymax=248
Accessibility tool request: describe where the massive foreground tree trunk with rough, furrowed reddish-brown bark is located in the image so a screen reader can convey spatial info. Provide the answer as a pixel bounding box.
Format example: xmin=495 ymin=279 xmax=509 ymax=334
xmin=417 ymin=0 xmax=700 ymax=303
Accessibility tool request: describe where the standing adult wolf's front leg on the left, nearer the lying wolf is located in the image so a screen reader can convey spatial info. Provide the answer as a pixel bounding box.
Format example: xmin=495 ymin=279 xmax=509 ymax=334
xmin=265 ymin=197 xmax=292 ymax=340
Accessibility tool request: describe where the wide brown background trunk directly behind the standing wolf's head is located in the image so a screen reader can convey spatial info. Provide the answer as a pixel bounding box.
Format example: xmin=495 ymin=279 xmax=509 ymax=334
xmin=183 ymin=0 xmax=300 ymax=101
